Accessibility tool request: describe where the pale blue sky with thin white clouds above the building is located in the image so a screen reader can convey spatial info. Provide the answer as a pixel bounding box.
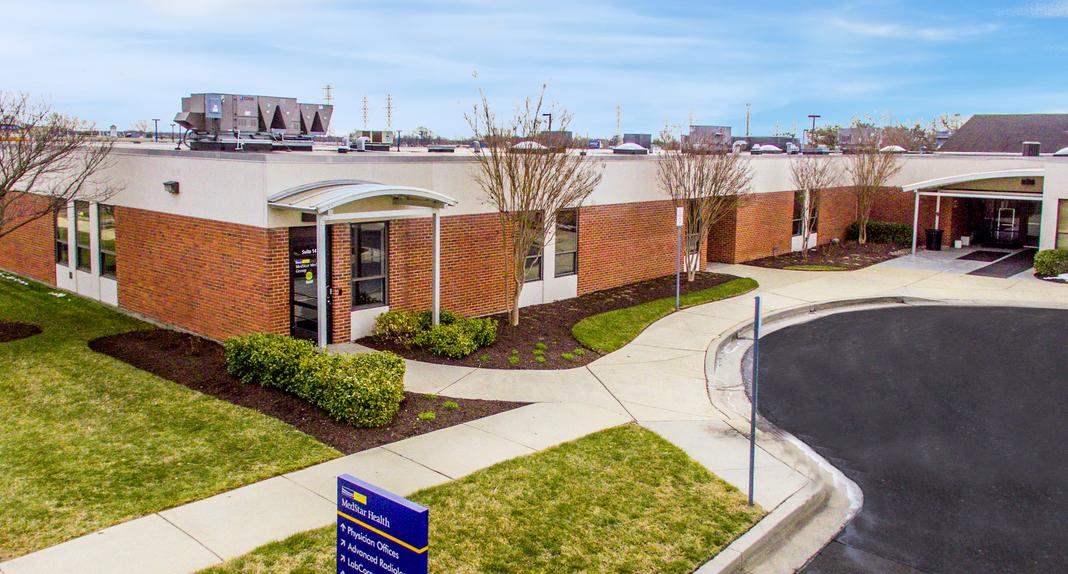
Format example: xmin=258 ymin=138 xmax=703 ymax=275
xmin=0 ymin=0 xmax=1068 ymax=136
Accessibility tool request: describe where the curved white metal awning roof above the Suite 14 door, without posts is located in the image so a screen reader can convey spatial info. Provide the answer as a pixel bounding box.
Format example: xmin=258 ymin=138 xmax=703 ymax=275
xmin=267 ymin=180 xmax=456 ymax=214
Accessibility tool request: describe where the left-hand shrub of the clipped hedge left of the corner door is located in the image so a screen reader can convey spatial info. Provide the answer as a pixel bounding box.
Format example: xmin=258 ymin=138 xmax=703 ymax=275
xmin=223 ymin=332 xmax=317 ymax=392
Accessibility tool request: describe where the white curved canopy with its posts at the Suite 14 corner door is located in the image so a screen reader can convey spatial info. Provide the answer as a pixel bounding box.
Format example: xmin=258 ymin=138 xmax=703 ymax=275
xmin=267 ymin=180 xmax=456 ymax=346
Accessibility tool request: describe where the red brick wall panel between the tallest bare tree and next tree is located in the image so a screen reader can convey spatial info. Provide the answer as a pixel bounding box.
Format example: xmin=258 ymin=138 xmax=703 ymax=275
xmin=579 ymin=200 xmax=676 ymax=295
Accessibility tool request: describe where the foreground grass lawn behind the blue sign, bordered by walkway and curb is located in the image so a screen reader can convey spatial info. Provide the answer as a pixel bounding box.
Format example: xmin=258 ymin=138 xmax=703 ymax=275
xmin=203 ymin=424 xmax=763 ymax=574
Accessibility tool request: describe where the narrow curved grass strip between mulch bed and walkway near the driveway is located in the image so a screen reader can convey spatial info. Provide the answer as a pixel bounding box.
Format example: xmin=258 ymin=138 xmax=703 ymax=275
xmin=571 ymin=277 xmax=758 ymax=353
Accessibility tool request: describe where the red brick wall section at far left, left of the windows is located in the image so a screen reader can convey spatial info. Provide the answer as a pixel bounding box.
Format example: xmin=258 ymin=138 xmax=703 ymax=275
xmin=0 ymin=191 xmax=56 ymax=285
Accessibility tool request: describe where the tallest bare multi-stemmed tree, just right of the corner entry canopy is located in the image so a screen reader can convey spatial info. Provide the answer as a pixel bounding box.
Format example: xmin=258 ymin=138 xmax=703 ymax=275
xmin=468 ymin=87 xmax=602 ymax=325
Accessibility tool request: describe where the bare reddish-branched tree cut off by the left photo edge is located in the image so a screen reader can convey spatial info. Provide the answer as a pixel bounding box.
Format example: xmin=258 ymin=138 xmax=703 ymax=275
xmin=0 ymin=93 xmax=114 ymax=237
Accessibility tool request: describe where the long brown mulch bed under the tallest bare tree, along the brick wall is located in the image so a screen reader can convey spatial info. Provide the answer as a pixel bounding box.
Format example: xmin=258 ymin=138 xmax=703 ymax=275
xmin=357 ymin=273 xmax=737 ymax=369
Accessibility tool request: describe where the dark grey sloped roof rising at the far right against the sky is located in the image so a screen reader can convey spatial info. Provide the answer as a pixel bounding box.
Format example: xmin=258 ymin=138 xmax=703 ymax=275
xmin=941 ymin=113 xmax=1068 ymax=154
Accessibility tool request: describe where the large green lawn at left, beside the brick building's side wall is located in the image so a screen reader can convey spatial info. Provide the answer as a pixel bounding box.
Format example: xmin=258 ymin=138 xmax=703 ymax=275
xmin=0 ymin=276 xmax=339 ymax=560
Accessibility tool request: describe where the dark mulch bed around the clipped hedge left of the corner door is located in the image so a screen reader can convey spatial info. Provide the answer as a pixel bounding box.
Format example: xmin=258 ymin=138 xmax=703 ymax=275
xmin=89 ymin=329 xmax=525 ymax=454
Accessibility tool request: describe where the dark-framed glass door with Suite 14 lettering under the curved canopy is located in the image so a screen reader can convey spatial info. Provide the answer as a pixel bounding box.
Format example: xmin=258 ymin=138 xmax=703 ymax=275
xmin=289 ymin=227 xmax=330 ymax=342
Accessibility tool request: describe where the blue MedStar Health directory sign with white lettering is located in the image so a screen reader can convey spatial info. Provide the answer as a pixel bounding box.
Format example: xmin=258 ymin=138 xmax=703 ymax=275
xmin=337 ymin=475 xmax=429 ymax=574
